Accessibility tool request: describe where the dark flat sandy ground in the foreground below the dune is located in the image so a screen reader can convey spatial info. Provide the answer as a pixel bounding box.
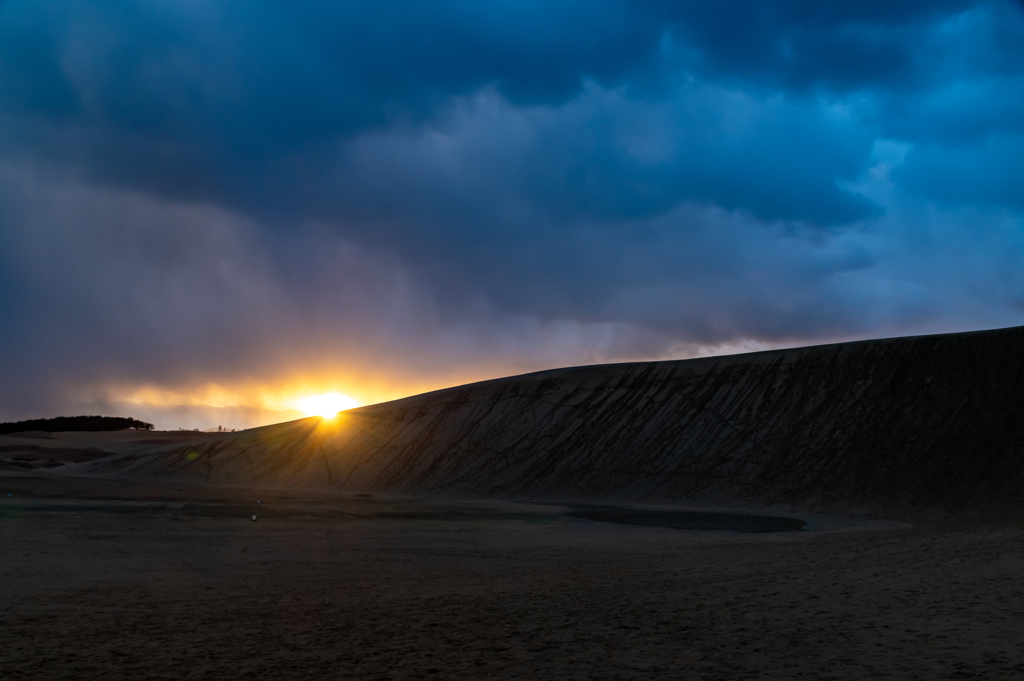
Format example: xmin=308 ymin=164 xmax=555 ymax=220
xmin=0 ymin=474 xmax=1024 ymax=680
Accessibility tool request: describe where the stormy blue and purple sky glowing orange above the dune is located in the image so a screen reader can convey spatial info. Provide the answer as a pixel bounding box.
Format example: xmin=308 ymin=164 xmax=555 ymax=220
xmin=0 ymin=0 xmax=1024 ymax=428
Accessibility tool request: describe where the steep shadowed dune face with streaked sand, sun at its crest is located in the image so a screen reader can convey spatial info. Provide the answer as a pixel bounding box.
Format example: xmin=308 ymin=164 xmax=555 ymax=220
xmin=69 ymin=328 xmax=1024 ymax=510
